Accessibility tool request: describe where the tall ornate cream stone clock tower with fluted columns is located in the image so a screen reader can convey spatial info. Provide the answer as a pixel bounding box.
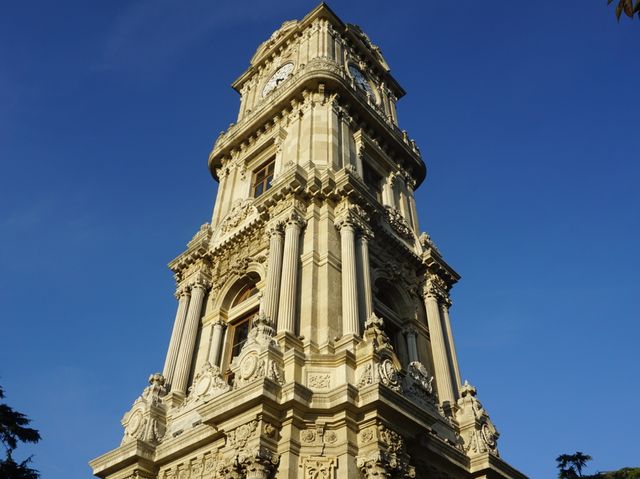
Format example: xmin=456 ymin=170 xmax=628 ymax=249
xmin=91 ymin=4 xmax=525 ymax=479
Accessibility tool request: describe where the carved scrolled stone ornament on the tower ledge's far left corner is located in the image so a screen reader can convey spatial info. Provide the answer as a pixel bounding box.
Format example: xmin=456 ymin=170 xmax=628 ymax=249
xmin=122 ymin=373 xmax=167 ymax=445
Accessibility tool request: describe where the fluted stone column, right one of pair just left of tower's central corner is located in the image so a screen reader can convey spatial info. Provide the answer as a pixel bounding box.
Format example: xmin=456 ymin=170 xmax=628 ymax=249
xmin=278 ymin=213 xmax=304 ymax=334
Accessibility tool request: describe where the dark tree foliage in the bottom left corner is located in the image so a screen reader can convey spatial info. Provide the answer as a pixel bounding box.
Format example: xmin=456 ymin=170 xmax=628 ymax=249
xmin=0 ymin=386 xmax=40 ymax=479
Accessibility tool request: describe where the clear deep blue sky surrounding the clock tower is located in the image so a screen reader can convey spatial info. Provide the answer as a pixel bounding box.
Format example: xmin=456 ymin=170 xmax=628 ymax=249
xmin=0 ymin=0 xmax=640 ymax=479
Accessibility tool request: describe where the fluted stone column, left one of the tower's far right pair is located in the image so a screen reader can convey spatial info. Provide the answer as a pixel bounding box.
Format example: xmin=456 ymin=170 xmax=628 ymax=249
xmin=425 ymin=287 xmax=455 ymax=404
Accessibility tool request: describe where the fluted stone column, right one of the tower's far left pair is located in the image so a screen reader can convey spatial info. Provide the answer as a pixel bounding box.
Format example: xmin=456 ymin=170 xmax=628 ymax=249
xmin=172 ymin=278 xmax=207 ymax=394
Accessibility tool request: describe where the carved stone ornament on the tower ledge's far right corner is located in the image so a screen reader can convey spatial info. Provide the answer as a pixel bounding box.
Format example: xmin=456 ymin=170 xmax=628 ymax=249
xmin=456 ymin=381 xmax=500 ymax=456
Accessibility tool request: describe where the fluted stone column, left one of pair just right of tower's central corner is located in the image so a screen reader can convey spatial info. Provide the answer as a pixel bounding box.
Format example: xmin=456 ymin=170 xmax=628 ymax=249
xmin=335 ymin=217 xmax=359 ymax=335
